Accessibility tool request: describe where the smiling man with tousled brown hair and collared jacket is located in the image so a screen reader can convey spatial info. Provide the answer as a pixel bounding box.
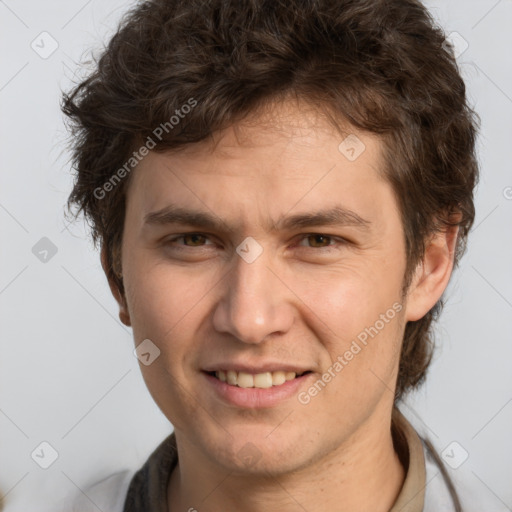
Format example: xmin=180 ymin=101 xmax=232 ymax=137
xmin=63 ymin=0 xmax=477 ymax=512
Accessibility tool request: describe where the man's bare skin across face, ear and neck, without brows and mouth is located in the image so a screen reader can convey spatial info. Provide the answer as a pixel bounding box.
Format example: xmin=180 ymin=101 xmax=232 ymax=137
xmin=102 ymin=101 xmax=457 ymax=512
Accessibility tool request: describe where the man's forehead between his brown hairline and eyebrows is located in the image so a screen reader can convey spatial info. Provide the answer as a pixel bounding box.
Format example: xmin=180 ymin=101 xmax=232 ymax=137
xmin=124 ymin=98 xmax=393 ymax=236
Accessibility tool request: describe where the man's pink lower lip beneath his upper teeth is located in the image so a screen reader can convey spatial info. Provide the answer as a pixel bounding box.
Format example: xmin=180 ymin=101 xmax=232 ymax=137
xmin=201 ymin=372 xmax=313 ymax=409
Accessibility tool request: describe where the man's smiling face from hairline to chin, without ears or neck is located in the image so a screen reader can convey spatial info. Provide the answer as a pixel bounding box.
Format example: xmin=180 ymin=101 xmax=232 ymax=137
xmin=117 ymin=103 xmax=412 ymax=473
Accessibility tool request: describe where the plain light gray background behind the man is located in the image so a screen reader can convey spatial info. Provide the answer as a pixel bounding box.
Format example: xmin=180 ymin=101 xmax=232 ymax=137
xmin=0 ymin=0 xmax=512 ymax=512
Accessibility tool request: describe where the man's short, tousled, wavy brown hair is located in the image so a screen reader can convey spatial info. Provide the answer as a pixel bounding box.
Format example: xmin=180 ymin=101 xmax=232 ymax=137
xmin=62 ymin=0 xmax=478 ymax=399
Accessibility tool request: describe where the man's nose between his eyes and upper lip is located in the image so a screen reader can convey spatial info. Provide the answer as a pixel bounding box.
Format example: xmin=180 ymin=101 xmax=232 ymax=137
xmin=213 ymin=247 xmax=294 ymax=344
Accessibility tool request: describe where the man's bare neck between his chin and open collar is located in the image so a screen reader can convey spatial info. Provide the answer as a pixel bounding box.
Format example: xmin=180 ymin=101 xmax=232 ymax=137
xmin=168 ymin=408 xmax=405 ymax=512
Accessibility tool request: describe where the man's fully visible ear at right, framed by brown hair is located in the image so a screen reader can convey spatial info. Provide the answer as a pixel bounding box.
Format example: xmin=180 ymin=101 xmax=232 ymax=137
xmin=405 ymin=226 xmax=459 ymax=321
